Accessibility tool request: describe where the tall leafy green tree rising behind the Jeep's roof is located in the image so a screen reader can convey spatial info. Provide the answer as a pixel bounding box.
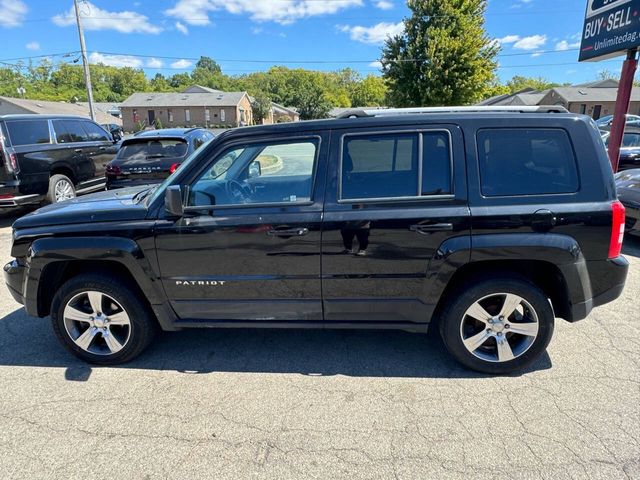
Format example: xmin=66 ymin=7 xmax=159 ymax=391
xmin=382 ymin=0 xmax=499 ymax=107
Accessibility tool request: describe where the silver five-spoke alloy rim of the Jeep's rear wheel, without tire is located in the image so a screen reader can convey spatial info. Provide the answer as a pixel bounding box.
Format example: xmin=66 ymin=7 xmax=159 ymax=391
xmin=460 ymin=293 xmax=540 ymax=362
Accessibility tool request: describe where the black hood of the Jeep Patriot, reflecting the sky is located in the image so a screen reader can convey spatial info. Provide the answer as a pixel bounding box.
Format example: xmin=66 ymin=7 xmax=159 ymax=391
xmin=13 ymin=186 xmax=149 ymax=229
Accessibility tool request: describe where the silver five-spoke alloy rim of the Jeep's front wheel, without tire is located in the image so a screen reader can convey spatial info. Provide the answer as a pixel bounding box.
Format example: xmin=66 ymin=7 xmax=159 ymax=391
xmin=63 ymin=291 xmax=131 ymax=355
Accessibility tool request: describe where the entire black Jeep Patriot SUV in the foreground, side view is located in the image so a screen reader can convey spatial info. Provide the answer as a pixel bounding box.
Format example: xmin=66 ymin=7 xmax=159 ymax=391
xmin=4 ymin=107 xmax=628 ymax=374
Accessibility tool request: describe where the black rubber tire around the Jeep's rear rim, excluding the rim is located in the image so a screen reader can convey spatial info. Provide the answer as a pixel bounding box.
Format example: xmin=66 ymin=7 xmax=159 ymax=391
xmin=440 ymin=278 xmax=555 ymax=375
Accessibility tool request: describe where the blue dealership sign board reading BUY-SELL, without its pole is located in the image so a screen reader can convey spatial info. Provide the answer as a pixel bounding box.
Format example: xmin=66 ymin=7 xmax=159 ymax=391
xmin=580 ymin=0 xmax=640 ymax=62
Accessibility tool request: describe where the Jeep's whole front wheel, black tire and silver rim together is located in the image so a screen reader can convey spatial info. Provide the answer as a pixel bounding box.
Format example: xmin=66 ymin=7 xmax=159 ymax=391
xmin=51 ymin=274 xmax=157 ymax=365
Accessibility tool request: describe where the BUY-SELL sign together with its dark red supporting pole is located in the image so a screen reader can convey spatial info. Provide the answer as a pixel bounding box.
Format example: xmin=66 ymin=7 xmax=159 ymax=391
xmin=579 ymin=0 xmax=640 ymax=172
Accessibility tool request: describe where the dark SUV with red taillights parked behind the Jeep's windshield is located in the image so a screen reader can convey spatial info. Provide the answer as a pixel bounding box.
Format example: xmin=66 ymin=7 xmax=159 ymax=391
xmin=105 ymin=128 xmax=214 ymax=190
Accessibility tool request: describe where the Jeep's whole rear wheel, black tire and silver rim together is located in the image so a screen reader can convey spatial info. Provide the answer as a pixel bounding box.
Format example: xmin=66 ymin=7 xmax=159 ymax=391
xmin=440 ymin=277 xmax=554 ymax=375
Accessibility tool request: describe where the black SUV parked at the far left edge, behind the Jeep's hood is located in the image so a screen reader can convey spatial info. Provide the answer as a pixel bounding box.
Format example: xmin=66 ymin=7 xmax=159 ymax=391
xmin=0 ymin=114 xmax=117 ymax=207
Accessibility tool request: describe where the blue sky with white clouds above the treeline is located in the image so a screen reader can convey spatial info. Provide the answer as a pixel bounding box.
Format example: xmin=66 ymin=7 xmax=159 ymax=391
xmin=0 ymin=0 xmax=622 ymax=83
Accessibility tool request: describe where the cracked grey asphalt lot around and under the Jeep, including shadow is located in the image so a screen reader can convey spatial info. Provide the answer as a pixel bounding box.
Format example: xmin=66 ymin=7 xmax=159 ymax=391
xmin=0 ymin=208 xmax=640 ymax=480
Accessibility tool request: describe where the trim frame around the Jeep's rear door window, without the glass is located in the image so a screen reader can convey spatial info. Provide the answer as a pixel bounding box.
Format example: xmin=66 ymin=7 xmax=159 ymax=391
xmin=337 ymin=128 xmax=455 ymax=204
